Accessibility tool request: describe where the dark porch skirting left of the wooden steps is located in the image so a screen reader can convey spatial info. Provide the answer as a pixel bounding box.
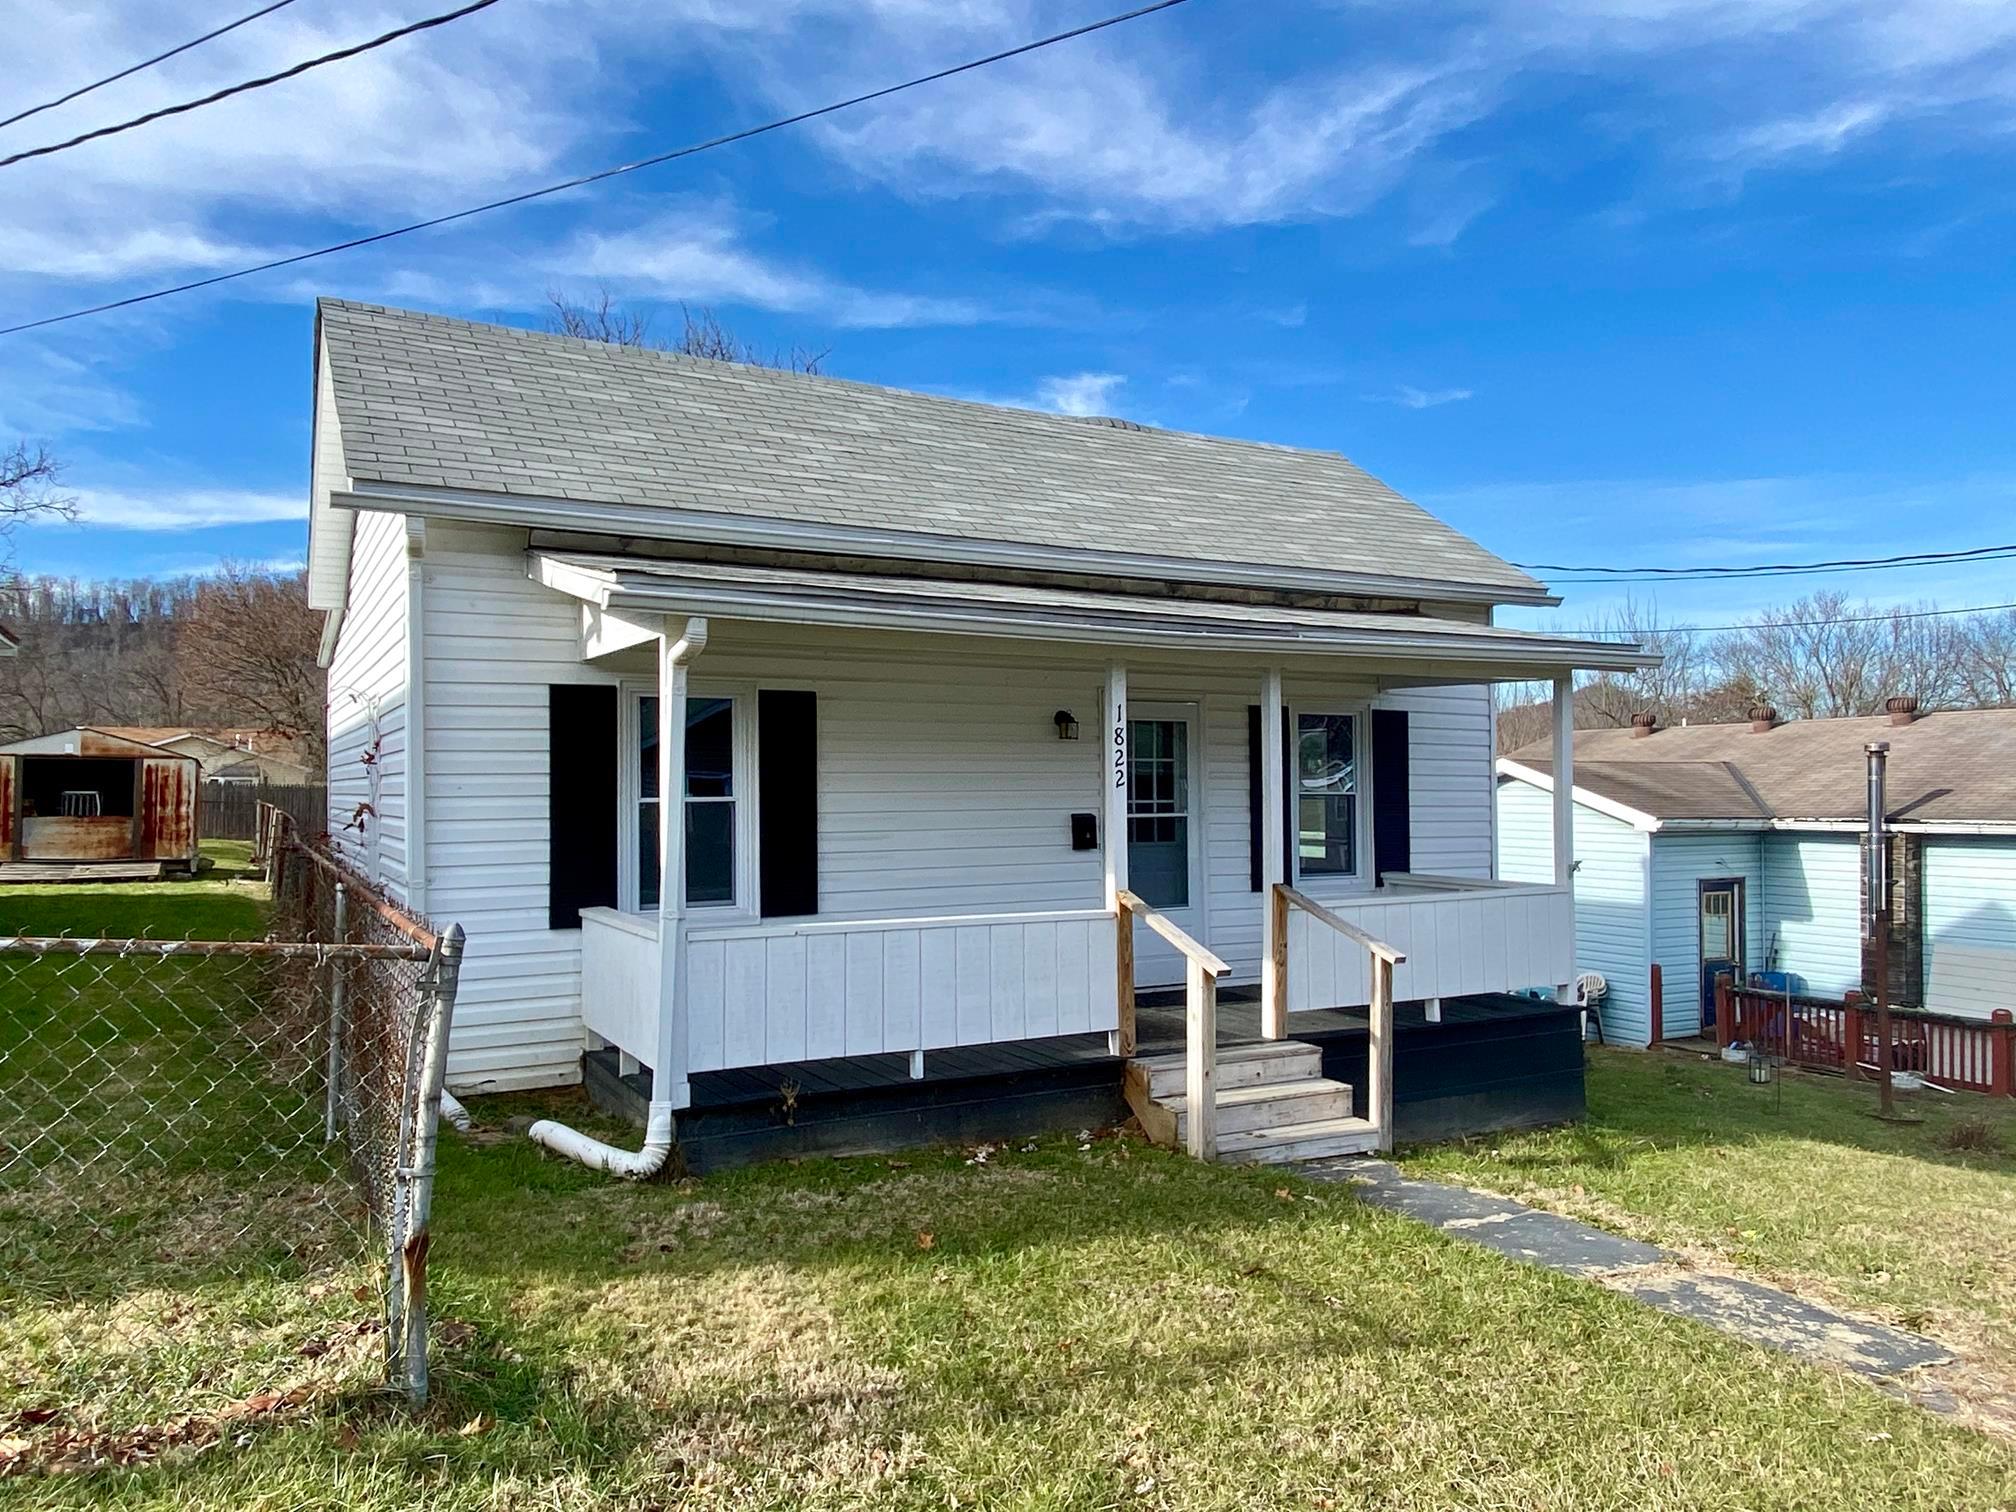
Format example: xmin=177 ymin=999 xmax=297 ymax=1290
xmin=583 ymin=1034 xmax=1127 ymax=1175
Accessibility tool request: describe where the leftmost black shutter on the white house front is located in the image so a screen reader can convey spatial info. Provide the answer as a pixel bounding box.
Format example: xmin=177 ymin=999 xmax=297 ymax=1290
xmin=546 ymin=683 xmax=623 ymax=929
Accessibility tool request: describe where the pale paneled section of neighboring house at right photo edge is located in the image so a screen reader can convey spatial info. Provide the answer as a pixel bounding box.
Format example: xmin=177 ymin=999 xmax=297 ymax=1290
xmin=1925 ymin=837 xmax=2016 ymax=1018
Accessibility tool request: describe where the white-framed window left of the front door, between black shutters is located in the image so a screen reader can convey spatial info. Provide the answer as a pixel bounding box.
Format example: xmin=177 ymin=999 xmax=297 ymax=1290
xmin=617 ymin=679 xmax=756 ymax=915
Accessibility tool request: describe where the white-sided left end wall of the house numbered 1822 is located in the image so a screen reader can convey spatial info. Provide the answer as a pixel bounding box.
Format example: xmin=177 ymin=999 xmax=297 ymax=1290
xmin=327 ymin=512 xmax=407 ymax=903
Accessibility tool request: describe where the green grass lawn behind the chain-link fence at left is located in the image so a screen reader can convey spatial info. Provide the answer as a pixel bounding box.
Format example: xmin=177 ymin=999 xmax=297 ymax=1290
xmin=0 ymin=841 xmax=361 ymax=1306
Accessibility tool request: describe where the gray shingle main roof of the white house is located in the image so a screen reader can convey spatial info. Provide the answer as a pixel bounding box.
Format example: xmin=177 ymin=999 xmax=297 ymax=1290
xmin=319 ymin=298 xmax=1542 ymax=601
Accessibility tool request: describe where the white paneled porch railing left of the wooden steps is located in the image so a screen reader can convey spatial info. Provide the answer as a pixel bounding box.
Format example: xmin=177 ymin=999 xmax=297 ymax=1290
xmin=581 ymin=909 xmax=1119 ymax=1073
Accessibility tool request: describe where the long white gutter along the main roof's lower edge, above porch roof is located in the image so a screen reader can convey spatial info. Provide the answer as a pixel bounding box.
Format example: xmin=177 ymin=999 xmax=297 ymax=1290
xmin=329 ymin=478 xmax=1560 ymax=609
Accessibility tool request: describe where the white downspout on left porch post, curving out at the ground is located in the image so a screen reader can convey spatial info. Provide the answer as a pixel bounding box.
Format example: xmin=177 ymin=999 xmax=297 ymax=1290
xmin=526 ymin=617 xmax=708 ymax=1181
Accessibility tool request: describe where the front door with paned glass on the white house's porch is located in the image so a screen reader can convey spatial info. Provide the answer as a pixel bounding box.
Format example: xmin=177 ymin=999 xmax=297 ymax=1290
xmin=1127 ymin=704 xmax=1204 ymax=988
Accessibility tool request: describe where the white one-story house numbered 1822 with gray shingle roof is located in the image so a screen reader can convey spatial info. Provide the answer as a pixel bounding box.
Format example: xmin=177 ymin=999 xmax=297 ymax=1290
xmin=308 ymin=300 xmax=1643 ymax=1159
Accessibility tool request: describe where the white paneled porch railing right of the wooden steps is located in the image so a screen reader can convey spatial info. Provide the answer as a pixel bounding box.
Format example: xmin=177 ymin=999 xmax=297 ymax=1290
xmin=1284 ymin=873 xmax=1574 ymax=1014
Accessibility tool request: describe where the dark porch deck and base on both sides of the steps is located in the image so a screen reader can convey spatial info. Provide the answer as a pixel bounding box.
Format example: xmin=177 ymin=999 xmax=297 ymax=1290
xmin=585 ymin=988 xmax=1585 ymax=1173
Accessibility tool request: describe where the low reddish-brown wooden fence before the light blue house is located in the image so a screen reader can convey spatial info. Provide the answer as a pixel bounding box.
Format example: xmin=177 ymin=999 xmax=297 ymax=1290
xmin=1716 ymin=978 xmax=2016 ymax=1097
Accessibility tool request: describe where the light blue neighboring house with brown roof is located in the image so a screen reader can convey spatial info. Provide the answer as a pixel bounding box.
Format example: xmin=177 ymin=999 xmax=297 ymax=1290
xmin=1498 ymin=700 xmax=2016 ymax=1044
